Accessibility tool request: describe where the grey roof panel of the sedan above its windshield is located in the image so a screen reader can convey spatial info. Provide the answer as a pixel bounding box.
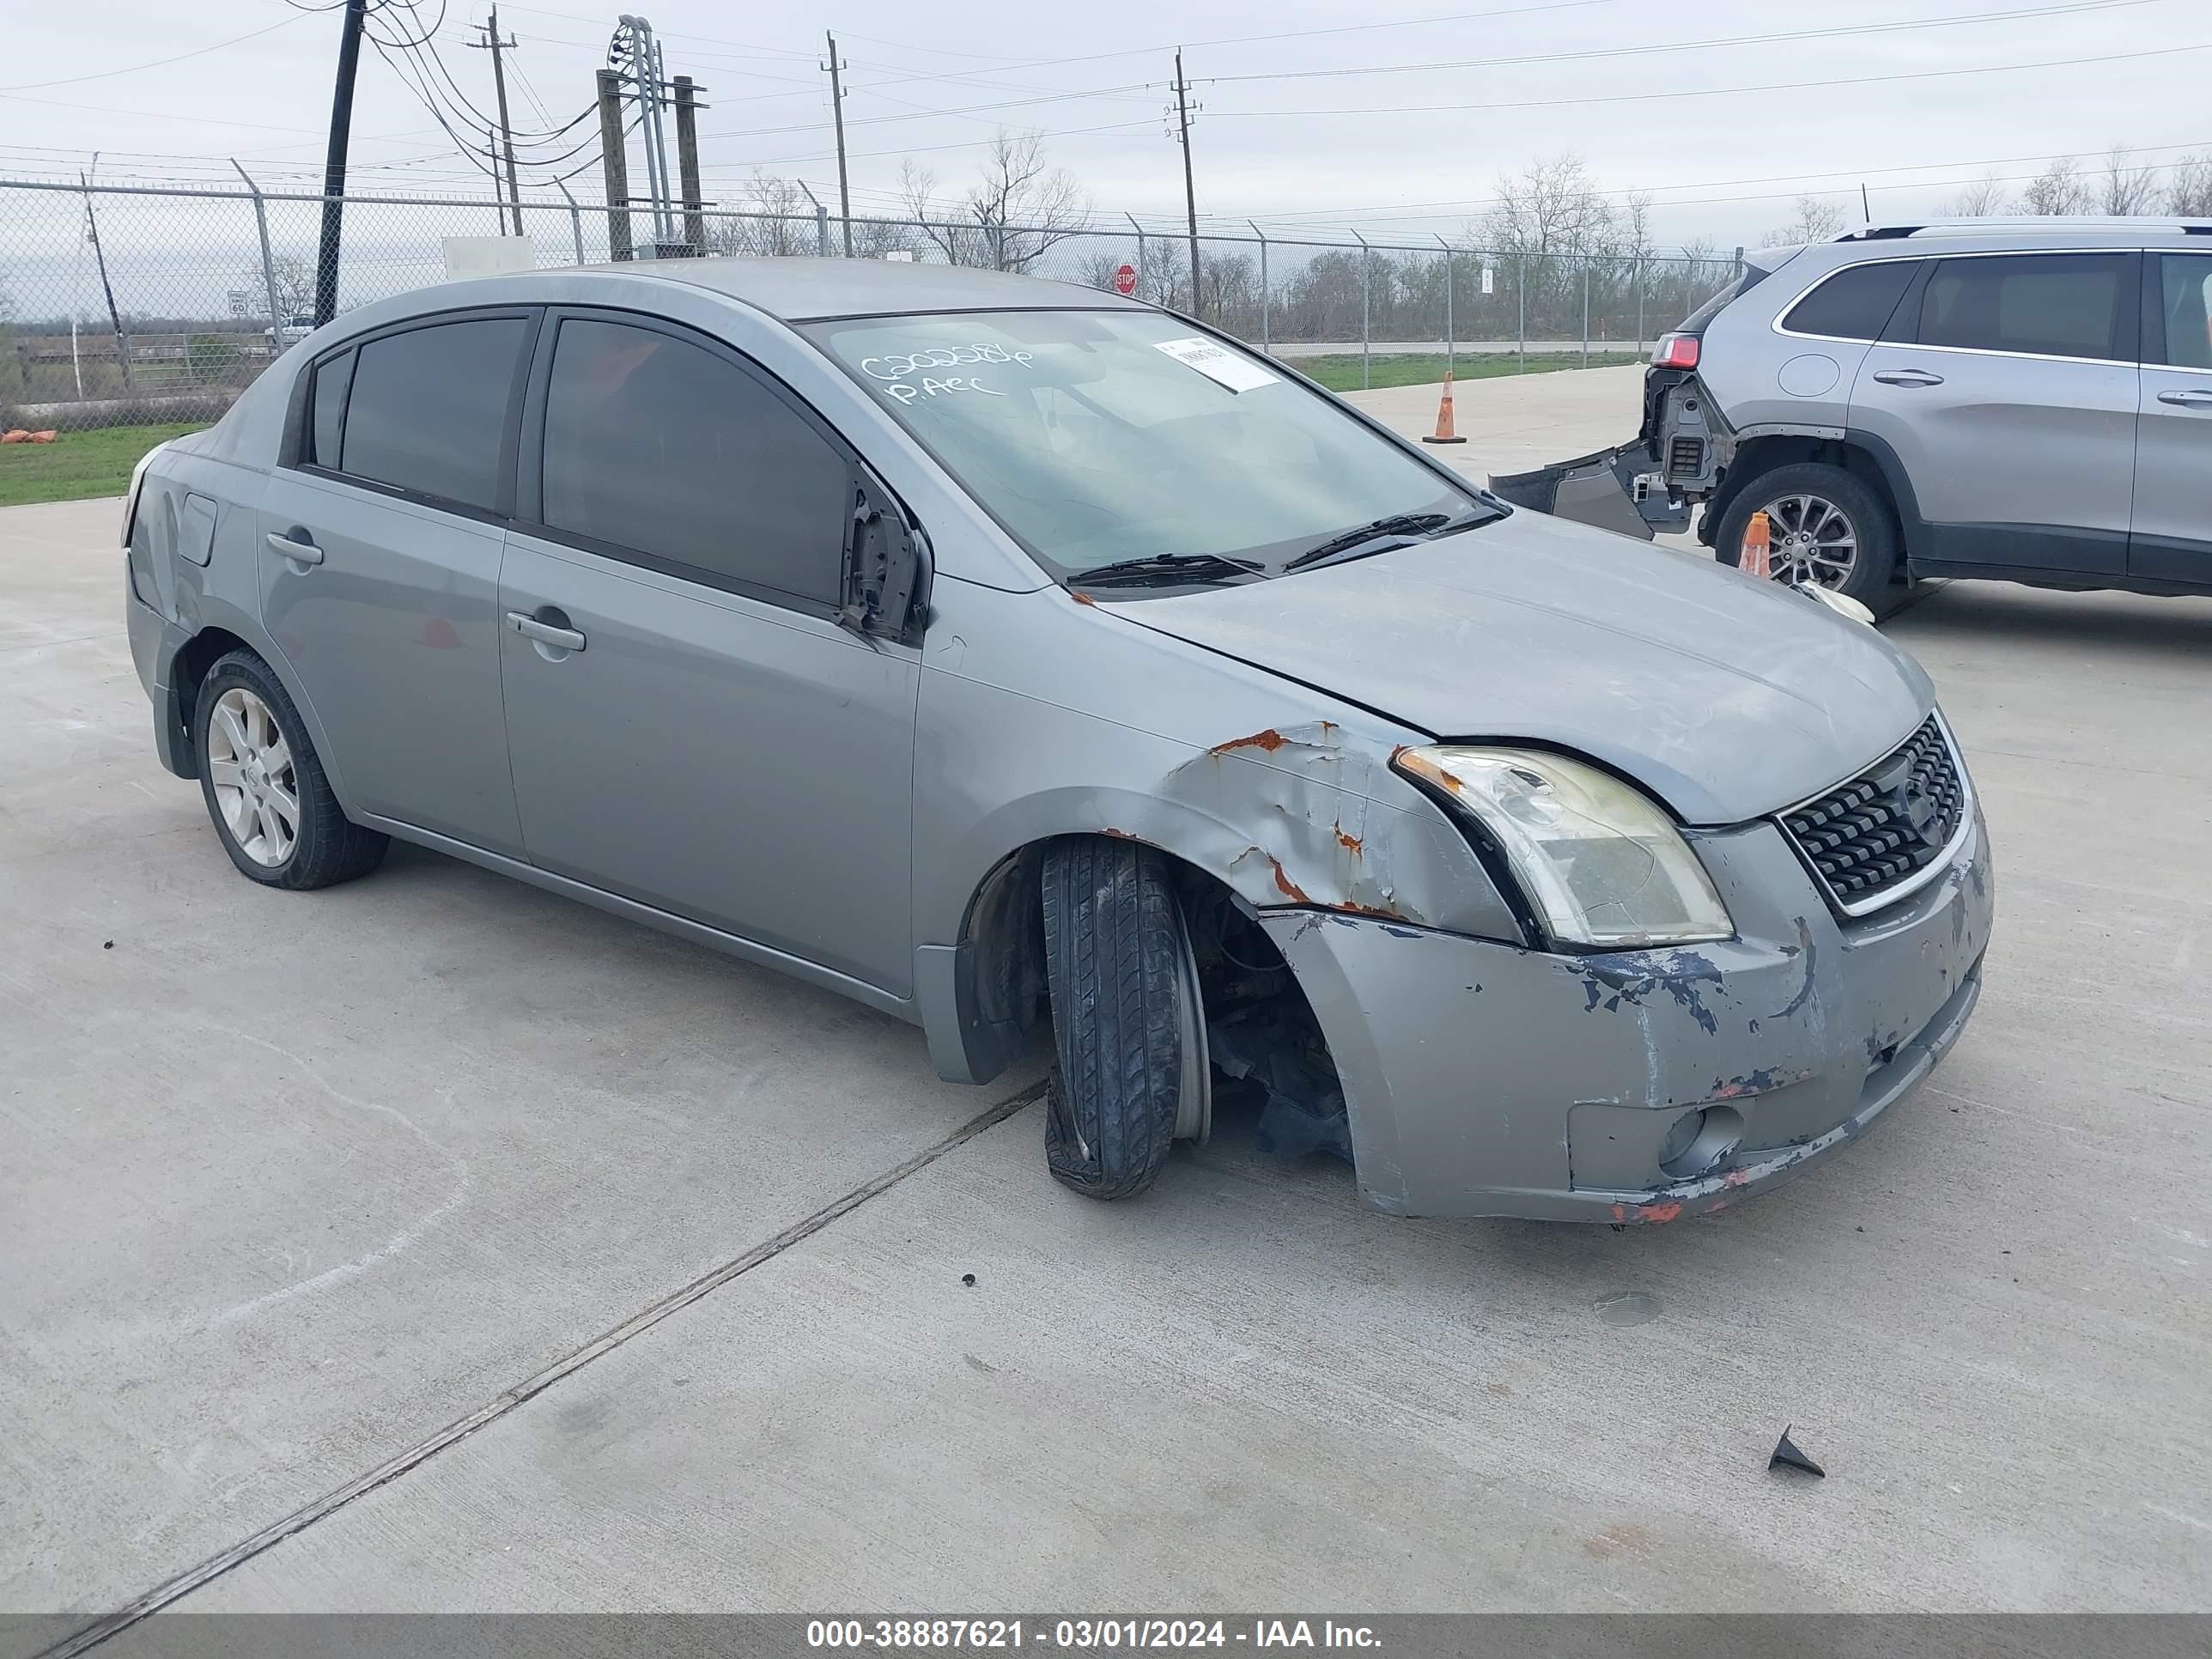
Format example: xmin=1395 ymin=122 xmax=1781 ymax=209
xmin=615 ymin=257 xmax=1152 ymax=323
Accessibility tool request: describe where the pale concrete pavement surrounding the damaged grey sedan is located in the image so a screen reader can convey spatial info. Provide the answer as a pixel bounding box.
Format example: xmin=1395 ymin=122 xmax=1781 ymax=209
xmin=0 ymin=372 xmax=2212 ymax=1646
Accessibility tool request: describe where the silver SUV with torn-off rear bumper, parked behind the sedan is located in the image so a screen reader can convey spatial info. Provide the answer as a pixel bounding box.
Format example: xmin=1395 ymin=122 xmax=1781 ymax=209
xmin=1493 ymin=219 xmax=2212 ymax=604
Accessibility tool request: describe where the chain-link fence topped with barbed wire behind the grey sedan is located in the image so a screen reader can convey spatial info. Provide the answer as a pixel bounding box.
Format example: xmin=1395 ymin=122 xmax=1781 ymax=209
xmin=0 ymin=181 xmax=1741 ymax=434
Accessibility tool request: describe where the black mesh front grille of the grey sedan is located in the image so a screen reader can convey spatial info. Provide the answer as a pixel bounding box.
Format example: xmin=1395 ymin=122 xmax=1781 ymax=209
xmin=1781 ymin=714 xmax=1966 ymax=911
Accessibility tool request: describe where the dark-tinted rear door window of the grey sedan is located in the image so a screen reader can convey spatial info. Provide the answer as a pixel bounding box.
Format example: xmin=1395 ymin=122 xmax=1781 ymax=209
xmin=333 ymin=316 xmax=526 ymax=514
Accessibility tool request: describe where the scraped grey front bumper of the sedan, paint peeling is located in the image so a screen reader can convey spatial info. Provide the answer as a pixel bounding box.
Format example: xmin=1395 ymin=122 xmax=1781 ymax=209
xmin=1265 ymin=814 xmax=1996 ymax=1224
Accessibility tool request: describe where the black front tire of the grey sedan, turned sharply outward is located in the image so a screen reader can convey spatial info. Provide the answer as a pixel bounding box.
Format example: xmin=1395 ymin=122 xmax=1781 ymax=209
xmin=1044 ymin=838 xmax=1203 ymax=1199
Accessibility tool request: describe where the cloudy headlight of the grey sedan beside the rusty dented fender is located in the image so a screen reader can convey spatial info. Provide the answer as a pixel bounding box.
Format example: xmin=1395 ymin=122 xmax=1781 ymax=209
xmin=1394 ymin=745 xmax=1736 ymax=951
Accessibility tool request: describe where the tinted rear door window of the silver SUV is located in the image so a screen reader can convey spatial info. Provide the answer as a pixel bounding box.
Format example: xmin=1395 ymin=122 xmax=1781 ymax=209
xmin=1920 ymin=254 xmax=2135 ymax=358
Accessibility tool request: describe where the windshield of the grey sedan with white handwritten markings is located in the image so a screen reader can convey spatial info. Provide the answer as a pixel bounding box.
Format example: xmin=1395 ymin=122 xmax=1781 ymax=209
xmin=805 ymin=312 xmax=1498 ymax=584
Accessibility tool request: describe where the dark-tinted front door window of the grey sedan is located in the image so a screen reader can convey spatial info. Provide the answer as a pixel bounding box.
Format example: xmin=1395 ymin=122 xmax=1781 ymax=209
xmin=539 ymin=319 xmax=852 ymax=604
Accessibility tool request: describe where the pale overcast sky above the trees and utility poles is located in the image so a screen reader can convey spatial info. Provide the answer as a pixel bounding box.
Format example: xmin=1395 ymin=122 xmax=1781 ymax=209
xmin=0 ymin=0 xmax=2212 ymax=246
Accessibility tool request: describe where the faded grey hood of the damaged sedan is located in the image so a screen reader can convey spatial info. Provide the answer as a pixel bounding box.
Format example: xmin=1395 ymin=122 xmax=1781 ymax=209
xmin=1115 ymin=511 xmax=1936 ymax=825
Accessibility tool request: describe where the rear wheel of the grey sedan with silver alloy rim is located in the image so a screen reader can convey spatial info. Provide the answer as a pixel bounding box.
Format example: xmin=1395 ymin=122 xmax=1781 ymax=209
xmin=192 ymin=650 xmax=389 ymax=891
